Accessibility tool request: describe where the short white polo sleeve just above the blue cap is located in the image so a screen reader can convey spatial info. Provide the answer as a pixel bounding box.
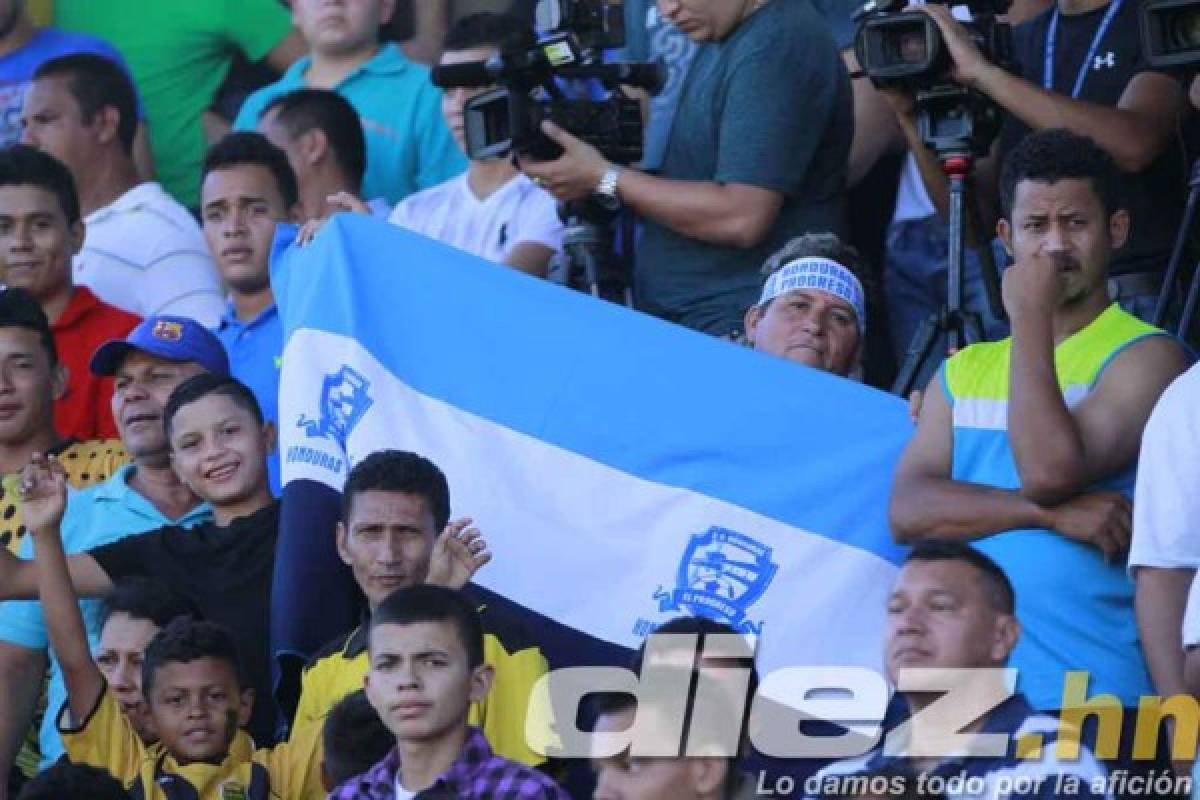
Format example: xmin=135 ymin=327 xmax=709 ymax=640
xmin=138 ymin=249 xmax=224 ymax=329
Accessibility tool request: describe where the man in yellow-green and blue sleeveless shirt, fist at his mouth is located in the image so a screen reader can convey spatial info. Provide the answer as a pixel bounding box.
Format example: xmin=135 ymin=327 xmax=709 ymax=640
xmin=890 ymin=130 xmax=1186 ymax=791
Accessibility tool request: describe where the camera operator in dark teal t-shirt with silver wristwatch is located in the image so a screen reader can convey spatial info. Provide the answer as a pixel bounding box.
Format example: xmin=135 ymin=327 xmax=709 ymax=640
xmin=521 ymin=0 xmax=853 ymax=336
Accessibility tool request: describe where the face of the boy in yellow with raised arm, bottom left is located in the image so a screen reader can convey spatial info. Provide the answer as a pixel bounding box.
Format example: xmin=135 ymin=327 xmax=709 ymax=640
xmin=146 ymin=657 xmax=254 ymax=764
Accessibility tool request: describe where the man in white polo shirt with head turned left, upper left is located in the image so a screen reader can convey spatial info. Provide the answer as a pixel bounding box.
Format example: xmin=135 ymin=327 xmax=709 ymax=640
xmin=22 ymin=54 xmax=224 ymax=327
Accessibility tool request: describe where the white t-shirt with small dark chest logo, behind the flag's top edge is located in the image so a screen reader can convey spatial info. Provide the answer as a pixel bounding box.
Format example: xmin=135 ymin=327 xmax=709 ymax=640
xmin=388 ymin=173 xmax=563 ymax=263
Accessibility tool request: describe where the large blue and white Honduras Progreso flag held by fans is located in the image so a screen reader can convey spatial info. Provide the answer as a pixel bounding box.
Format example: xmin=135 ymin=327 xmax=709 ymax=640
xmin=271 ymin=215 xmax=912 ymax=673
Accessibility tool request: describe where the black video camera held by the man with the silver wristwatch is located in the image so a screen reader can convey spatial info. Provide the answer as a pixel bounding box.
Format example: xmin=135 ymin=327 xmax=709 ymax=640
xmin=433 ymin=0 xmax=666 ymax=164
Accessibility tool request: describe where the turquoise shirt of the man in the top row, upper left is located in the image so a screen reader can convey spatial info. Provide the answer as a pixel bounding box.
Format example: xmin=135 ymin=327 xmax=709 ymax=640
xmin=233 ymin=43 xmax=467 ymax=205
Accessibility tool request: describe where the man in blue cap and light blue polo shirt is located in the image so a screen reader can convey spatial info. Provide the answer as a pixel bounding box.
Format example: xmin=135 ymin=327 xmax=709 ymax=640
xmin=0 ymin=317 xmax=229 ymax=775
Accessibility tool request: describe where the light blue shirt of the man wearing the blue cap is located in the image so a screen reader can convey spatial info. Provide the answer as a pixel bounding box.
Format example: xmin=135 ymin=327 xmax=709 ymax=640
xmin=0 ymin=464 xmax=212 ymax=769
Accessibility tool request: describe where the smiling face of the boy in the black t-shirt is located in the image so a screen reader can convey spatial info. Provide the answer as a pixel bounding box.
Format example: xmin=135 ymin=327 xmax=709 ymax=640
xmin=169 ymin=393 xmax=272 ymax=507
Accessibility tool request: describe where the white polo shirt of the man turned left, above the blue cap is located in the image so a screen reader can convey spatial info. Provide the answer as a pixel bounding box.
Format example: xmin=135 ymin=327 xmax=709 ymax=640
xmin=74 ymin=181 xmax=224 ymax=327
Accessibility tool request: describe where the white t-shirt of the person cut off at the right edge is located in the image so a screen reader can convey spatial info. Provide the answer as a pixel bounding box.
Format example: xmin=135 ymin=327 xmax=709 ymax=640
xmin=1129 ymin=365 xmax=1200 ymax=570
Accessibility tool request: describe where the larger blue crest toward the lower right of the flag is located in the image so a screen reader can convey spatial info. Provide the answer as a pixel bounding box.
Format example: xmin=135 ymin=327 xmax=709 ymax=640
xmin=654 ymin=525 xmax=779 ymax=634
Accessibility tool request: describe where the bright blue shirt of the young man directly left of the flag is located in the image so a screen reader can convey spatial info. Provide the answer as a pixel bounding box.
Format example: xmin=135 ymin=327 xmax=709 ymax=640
xmin=216 ymin=305 xmax=283 ymax=497
